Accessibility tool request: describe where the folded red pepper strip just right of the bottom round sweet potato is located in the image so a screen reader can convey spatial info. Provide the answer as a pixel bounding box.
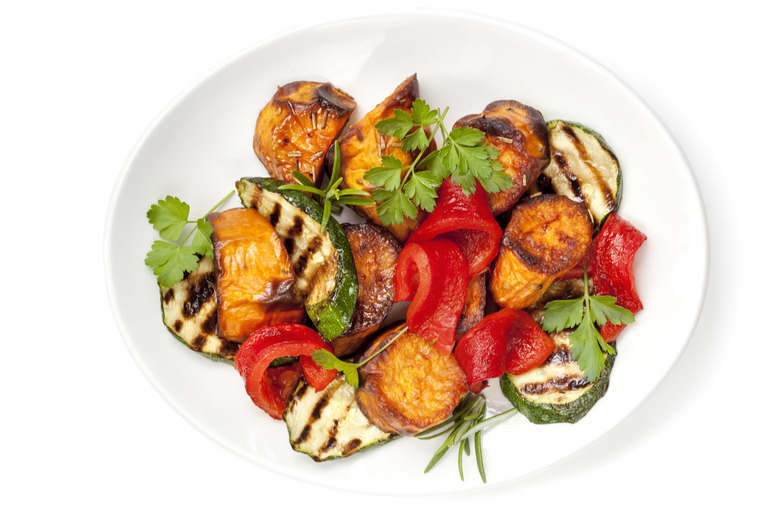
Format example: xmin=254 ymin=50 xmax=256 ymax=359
xmin=454 ymin=308 xmax=555 ymax=384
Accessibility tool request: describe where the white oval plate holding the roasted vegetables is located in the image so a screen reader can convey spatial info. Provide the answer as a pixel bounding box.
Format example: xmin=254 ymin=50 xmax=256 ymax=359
xmin=105 ymin=13 xmax=708 ymax=494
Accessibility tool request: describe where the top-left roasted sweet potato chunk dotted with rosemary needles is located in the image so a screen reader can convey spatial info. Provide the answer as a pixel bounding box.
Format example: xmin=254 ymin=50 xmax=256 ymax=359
xmin=254 ymin=81 xmax=355 ymax=185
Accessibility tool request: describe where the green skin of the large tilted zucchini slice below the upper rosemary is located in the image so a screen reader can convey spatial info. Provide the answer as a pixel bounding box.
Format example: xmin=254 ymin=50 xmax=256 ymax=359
xmin=236 ymin=178 xmax=358 ymax=341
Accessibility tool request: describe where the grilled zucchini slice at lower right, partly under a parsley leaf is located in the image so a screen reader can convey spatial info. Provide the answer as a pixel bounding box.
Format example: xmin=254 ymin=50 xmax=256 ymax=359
xmin=500 ymin=330 xmax=617 ymax=424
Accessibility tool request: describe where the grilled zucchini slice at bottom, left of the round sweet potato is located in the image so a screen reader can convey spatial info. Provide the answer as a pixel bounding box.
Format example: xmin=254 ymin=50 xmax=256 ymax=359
xmin=282 ymin=375 xmax=398 ymax=461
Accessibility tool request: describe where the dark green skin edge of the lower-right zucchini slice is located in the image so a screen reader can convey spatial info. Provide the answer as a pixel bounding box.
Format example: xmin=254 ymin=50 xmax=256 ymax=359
xmin=499 ymin=343 xmax=617 ymax=424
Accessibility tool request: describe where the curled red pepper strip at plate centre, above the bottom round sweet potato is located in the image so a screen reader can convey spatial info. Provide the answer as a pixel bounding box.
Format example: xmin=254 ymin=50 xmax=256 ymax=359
xmin=393 ymin=239 xmax=468 ymax=354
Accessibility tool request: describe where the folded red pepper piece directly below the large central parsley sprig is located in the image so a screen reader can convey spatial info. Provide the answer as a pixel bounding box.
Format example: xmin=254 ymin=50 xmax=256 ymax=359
xmin=407 ymin=178 xmax=503 ymax=279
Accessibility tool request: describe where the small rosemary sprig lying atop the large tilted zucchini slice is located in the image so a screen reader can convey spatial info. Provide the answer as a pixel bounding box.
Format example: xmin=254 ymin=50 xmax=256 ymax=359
xmin=279 ymin=141 xmax=376 ymax=233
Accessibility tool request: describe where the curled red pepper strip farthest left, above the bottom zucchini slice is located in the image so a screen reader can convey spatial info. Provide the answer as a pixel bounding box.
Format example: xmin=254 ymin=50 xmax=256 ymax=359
xmin=234 ymin=324 xmax=337 ymax=419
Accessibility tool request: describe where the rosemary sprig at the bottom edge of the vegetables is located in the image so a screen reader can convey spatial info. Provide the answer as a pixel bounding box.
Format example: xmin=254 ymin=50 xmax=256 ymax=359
xmin=415 ymin=392 xmax=517 ymax=482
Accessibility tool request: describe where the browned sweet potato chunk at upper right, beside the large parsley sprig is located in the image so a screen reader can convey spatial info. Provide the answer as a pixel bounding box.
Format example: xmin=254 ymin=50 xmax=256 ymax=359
xmin=453 ymin=100 xmax=550 ymax=215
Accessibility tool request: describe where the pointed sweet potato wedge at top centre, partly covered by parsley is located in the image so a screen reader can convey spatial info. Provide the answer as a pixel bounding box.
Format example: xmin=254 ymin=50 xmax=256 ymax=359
xmin=328 ymin=74 xmax=436 ymax=242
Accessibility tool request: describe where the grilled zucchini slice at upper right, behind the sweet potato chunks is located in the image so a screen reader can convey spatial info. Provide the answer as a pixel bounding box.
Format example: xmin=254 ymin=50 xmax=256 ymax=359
xmin=543 ymin=120 xmax=623 ymax=228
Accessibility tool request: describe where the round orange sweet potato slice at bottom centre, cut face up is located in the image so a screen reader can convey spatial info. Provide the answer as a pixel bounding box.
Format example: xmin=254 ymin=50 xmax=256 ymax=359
xmin=355 ymin=323 xmax=468 ymax=436
